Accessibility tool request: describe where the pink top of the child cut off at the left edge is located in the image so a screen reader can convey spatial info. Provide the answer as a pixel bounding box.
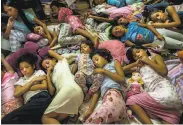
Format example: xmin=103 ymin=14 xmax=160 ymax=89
xmin=1 ymin=73 xmax=18 ymax=105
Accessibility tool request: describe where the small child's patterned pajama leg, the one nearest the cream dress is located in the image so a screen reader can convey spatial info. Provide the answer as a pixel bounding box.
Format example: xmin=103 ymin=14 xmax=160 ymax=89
xmin=74 ymin=71 xmax=88 ymax=95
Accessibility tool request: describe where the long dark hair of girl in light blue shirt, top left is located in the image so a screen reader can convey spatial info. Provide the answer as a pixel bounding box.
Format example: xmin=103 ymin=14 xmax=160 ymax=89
xmin=3 ymin=0 xmax=34 ymax=32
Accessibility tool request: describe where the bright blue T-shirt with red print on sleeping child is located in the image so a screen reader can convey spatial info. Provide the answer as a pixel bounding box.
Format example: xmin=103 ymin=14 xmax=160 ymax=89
xmin=121 ymin=22 xmax=154 ymax=44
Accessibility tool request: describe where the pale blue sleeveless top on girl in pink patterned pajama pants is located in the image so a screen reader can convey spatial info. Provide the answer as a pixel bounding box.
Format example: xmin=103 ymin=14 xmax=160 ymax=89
xmin=101 ymin=61 xmax=122 ymax=97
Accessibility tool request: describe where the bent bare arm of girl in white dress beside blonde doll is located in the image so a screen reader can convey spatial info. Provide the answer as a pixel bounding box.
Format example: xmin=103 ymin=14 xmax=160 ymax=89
xmin=140 ymin=55 xmax=168 ymax=76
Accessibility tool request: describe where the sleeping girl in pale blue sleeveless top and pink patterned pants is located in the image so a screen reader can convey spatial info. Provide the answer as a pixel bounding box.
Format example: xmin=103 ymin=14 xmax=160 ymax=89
xmin=84 ymin=49 xmax=127 ymax=124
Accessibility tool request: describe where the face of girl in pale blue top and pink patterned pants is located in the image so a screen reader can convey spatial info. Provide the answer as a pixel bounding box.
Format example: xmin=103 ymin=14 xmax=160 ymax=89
xmin=92 ymin=54 xmax=106 ymax=68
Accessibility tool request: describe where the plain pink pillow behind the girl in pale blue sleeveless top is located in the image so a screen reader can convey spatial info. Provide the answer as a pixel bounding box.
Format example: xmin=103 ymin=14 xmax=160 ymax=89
xmin=98 ymin=40 xmax=126 ymax=64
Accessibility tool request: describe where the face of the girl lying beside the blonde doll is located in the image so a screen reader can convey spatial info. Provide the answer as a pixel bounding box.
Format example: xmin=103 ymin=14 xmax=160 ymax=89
xmin=133 ymin=49 xmax=147 ymax=60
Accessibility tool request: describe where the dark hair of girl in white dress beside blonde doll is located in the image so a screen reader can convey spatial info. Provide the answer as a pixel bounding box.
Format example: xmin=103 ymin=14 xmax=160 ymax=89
xmin=126 ymin=45 xmax=151 ymax=63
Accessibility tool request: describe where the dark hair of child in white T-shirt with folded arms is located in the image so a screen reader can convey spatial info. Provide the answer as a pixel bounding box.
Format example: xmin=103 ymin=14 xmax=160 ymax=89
xmin=16 ymin=53 xmax=38 ymax=68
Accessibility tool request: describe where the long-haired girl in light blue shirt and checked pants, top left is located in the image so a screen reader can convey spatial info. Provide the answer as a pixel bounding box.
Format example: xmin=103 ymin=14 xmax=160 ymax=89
xmin=3 ymin=0 xmax=50 ymax=52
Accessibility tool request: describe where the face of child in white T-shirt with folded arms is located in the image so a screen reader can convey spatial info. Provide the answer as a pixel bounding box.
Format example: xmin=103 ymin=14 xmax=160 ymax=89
xmin=19 ymin=62 xmax=35 ymax=77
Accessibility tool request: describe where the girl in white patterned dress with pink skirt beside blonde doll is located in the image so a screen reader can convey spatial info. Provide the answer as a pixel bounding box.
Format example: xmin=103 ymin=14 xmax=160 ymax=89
xmin=126 ymin=46 xmax=183 ymax=124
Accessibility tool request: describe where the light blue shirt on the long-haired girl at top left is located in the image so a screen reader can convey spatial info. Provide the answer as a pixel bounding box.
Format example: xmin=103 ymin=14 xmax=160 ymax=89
xmin=13 ymin=11 xmax=35 ymax=34
